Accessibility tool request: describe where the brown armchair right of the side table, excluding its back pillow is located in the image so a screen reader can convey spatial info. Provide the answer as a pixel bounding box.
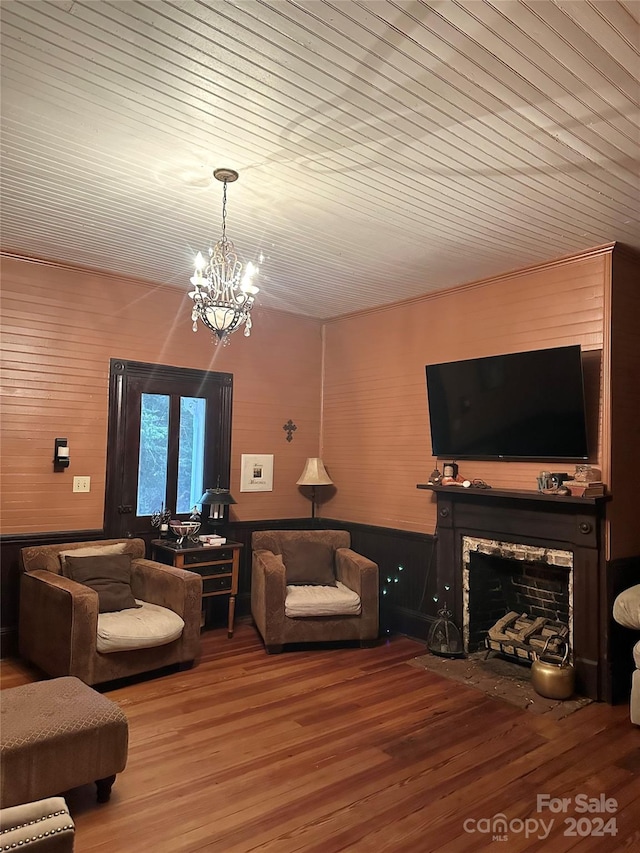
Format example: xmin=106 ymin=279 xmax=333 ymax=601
xmin=251 ymin=530 xmax=378 ymax=653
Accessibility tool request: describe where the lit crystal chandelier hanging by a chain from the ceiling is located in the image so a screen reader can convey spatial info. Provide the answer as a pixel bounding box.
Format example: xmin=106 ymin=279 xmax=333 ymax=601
xmin=189 ymin=169 xmax=259 ymax=344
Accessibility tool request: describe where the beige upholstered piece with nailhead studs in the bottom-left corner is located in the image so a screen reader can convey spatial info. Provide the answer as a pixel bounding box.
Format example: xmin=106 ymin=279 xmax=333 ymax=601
xmin=0 ymin=797 xmax=75 ymax=853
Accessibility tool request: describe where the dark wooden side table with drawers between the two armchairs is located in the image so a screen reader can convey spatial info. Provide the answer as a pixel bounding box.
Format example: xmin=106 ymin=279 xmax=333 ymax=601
xmin=151 ymin=539 xmax=243 ymax=637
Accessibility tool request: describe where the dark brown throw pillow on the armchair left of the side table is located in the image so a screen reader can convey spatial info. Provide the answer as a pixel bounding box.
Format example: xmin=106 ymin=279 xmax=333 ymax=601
xmin=67 ymin=554 xmax=142 ymax=613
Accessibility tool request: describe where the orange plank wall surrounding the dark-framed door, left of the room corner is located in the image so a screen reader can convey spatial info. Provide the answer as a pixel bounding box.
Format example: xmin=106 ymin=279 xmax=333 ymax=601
xmin=0 ymin=257 xmax=322 ymax=534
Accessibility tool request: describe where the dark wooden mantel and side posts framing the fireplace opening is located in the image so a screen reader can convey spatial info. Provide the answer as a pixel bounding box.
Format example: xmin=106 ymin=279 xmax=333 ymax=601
xmin=418 ymin=484 xmax=611 ymax=700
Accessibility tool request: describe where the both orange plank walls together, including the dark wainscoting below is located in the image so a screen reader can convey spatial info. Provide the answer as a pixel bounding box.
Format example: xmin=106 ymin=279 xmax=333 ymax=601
xmin=0 ymin=245 xmax=640 ymax=656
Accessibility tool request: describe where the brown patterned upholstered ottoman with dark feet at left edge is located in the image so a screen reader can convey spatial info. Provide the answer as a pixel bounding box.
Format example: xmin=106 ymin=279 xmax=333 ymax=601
xmin=0 ymin=676 xmax=129 ymax=808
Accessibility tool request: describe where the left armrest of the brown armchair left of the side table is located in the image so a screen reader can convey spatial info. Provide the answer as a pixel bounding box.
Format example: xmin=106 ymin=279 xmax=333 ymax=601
xmin=18 ymin=569 xmax=98 ymax=681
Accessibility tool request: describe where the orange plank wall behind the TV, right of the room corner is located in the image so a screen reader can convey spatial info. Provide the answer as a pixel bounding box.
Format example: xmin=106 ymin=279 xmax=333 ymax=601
xmin=322 ymin=246 xmax=612 ymax=533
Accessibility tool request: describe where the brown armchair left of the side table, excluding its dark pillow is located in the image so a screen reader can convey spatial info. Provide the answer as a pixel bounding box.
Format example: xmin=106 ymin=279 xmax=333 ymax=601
xmin=18 ymin=539 xmax=202 ymax=685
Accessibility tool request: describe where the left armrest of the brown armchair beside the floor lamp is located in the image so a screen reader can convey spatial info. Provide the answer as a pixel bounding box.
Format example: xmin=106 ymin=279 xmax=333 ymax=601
xmin=251 ymin=551 xmax=287 ymax=647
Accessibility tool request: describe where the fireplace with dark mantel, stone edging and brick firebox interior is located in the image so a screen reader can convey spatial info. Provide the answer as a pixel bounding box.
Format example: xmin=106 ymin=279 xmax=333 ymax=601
xmin=418 ymin=485 xmax=609 ymax=699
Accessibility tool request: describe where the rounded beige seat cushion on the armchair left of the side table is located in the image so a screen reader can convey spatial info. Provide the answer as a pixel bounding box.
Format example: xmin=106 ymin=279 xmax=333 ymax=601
xmin=97 ymin=599 xmax=184 ymax=654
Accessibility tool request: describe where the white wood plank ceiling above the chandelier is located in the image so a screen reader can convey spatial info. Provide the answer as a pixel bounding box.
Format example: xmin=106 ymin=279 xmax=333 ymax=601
xmin=1 ymin=0 xmax=640 ymax=318
